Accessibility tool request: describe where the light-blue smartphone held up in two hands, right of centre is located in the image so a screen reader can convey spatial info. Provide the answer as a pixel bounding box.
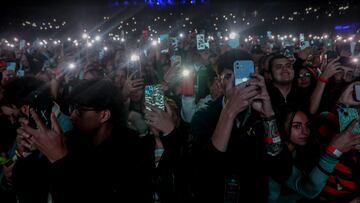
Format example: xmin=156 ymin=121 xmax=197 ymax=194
xmin=233 ymin=60 xmax=255 ymax=85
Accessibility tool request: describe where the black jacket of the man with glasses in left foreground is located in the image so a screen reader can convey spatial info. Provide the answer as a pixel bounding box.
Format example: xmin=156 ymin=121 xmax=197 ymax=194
xmin=51 ymin=128 xmax=152 ymax=203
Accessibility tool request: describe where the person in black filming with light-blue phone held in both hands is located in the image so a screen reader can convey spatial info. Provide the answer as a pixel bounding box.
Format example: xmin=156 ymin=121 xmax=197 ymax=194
xmin=191 ymin=50 xmax=291 ymax=202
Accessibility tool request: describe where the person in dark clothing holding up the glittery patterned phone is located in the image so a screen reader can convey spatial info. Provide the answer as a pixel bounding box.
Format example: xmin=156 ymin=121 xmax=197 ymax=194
xmin=142 ymin=99 xmax=190 ymax=203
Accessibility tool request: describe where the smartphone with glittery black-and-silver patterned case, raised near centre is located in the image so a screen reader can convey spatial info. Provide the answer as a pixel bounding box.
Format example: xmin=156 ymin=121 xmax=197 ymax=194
xmin=144 ymin=85 xmax=165 ymax=111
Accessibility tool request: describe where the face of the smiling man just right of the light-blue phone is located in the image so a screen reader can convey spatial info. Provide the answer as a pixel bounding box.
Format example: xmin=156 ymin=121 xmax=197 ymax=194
xmin=271 ymin=58 xmax=294 ymax=85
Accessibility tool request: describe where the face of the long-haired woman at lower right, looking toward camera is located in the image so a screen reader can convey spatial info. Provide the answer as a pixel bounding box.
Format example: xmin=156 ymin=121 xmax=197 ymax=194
xmin=287 ymin=111 xmax=310 ymax=146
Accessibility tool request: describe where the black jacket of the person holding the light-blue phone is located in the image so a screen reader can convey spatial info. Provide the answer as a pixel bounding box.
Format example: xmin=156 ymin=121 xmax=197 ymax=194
xmin=192 ymin=97 xmax=291 ymax=203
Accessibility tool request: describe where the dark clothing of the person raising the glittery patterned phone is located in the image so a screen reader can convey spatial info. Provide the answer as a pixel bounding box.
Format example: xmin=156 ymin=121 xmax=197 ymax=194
xmin=142 ymin=124 xmax=190 ymax=203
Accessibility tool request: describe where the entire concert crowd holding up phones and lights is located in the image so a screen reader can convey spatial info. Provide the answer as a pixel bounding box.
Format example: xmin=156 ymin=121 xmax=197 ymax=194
xmin=0 ymin=25 xmax=360 ymax=203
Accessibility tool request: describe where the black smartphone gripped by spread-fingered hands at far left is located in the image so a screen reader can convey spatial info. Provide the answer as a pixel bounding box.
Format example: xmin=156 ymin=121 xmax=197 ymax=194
xmin=28 ymin=90 xmax=53 ymax=129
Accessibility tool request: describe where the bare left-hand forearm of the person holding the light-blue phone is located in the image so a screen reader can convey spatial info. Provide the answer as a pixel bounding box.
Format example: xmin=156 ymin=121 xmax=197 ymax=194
xmin=211 ymin=108 xmax=235 ymax=152
